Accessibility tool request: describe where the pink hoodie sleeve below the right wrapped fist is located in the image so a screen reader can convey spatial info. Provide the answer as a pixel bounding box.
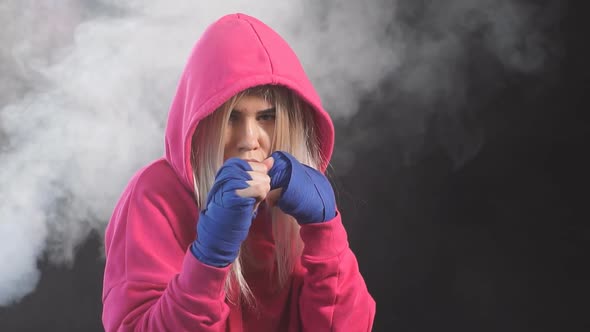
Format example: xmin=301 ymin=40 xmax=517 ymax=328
xmin=299 ymin=213 xmax=375 ymax=331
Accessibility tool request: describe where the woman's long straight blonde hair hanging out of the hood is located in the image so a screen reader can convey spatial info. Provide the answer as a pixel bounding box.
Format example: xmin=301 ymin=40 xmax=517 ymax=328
xmin=191 ymin=85 xmax=321 ymax=306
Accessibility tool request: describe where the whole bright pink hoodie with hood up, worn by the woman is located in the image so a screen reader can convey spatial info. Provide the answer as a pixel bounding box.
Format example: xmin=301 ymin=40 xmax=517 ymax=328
xmin=102 ymin=14 xmax=375 ymax=331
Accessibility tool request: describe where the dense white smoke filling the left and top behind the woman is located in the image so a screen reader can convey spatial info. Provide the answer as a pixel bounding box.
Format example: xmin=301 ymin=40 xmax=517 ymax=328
xmin=0 ymin=0 xmax=560 ymax=305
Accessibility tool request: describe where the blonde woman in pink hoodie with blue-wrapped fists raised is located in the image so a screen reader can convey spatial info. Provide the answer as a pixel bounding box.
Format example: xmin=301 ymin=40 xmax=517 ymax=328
xmin=103 ymin=14 xmax=375 ymax=331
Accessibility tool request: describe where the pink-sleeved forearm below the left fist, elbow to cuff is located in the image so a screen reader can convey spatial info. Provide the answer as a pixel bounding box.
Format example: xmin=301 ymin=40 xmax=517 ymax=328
xmin=103 ymin=252 xmax=229 ymax=331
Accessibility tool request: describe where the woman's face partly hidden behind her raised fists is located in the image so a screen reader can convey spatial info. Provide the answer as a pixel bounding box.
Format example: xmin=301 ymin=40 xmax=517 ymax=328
xmin=223 ymin=96 xmax=276 ymax=161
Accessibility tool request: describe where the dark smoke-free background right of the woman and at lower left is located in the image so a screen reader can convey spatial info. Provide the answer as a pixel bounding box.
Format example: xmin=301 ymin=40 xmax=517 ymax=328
xmin=0 ymin=1 xmax=590 ymax=331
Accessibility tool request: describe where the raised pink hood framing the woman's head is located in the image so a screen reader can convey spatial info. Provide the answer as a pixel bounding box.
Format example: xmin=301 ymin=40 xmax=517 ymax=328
xmin=166 ymin=14 xmax=334 ymax=192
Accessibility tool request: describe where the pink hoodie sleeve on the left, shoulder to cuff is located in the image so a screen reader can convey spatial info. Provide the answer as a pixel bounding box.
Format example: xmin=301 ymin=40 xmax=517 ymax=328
xmin=102 ymin=169 xmax=229 ymax=331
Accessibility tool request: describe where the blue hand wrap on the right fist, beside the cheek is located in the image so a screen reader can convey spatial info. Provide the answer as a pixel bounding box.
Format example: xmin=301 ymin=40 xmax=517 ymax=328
xmin=268 ymin=151 xmax=336 ymax=224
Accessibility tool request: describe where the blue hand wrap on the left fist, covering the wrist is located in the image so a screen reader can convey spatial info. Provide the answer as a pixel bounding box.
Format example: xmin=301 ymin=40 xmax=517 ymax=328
xmin=191 ymin=158 xmax=256 ymax=267
